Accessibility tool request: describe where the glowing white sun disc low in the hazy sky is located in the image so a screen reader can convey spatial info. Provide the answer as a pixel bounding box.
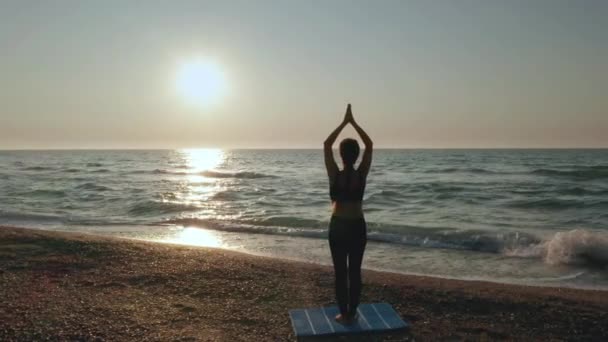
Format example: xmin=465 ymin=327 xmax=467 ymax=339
xmin=176 ymin=59 xmax=226 ymax=105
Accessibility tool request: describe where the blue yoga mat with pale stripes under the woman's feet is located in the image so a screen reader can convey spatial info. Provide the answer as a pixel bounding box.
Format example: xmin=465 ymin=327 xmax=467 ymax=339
xmin=289 ymin=303 xmax=409 ymax=337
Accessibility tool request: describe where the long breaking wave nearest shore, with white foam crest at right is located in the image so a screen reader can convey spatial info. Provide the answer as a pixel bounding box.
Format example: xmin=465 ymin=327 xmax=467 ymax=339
xmin=160 ymin=217 xmax=608 ymax=267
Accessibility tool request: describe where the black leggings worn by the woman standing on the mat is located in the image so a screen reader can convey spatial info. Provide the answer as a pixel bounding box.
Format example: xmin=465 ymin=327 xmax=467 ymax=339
xmin=329 ymin=216 xmax=367 ymax=315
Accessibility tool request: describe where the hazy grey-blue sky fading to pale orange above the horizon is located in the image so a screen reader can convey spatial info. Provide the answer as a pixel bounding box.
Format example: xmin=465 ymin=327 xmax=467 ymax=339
xmin=0 ymin=0 xmax=608 ymax=149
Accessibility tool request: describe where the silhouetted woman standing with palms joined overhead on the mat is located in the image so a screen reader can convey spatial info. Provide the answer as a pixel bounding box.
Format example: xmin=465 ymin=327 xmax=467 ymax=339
xmin=324 ymin=104 xmax=372 ymax=324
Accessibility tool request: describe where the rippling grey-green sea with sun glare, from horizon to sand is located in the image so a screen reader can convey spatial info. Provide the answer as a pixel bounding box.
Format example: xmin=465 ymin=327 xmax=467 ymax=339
xmin=0 ymin=149 xmax=608 ymax=290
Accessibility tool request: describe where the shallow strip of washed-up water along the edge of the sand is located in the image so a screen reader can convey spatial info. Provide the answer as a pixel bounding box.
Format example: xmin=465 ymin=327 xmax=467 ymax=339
xmin=41 ymin=225 xmax=608 ymax=291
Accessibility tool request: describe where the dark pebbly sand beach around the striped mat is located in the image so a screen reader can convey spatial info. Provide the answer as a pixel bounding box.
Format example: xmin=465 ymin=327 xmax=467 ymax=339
xmin=0 ymin=227 xmax=608 ymax=341
